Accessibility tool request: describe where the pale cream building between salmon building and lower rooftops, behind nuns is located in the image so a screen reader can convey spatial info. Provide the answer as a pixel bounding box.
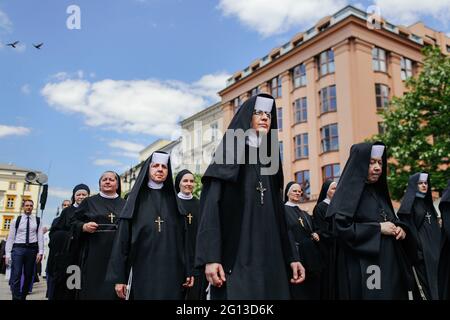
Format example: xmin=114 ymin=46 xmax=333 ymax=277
xmin=180 ymin=103 xmax=224 ymax=174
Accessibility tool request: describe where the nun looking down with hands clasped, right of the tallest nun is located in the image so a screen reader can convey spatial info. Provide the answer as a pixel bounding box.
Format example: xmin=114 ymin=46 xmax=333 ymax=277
xmin=327 ymin=142 xmax=417 ymax=300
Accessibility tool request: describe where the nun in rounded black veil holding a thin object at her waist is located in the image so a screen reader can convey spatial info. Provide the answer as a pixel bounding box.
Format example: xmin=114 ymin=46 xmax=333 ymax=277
xmin=72 ymin=171 xmax=125 ymax=300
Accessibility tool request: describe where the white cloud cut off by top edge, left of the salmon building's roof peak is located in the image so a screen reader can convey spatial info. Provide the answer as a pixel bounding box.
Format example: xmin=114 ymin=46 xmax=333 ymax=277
xmin=218 ymin=0 xmax=348 ymax=36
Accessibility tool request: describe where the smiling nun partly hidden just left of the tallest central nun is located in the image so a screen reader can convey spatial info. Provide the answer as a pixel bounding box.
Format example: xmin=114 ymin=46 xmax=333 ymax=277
xmin=175 ymin=169 xmax=208 ymax=300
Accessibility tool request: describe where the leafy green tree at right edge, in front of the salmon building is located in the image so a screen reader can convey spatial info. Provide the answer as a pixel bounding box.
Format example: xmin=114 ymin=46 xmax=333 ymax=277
xmin=371 ymin=47 xmax=450 ymax=200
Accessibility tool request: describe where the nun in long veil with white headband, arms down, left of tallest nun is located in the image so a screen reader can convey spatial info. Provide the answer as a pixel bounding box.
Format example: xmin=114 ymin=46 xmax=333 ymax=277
xmin=107 ymin=151 xmax=194 ymax=300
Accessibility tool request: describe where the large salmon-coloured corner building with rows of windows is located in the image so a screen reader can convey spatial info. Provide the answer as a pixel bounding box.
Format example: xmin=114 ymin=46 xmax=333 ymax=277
xmin=219 ymin=6 xmax=450 ymax=210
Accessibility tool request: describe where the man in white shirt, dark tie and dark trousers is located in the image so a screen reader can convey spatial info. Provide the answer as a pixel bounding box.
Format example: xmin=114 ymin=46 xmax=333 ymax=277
xmin=6 ymin=200 xmax=44 ymax=300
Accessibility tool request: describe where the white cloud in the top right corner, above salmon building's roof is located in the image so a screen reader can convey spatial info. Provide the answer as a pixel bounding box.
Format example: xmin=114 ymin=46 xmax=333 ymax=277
xmin=374 ymin=0 xmax=450 ymax=26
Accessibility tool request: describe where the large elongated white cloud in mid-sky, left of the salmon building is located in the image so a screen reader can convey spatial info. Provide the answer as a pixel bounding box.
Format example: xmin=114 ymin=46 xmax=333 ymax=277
xmin=41 ymin=73 xmax=229 ymax=137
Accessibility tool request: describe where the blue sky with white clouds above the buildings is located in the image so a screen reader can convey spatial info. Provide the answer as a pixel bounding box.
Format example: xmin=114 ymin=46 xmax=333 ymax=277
xmin=0 ymin=0 xmax=450 ymax=225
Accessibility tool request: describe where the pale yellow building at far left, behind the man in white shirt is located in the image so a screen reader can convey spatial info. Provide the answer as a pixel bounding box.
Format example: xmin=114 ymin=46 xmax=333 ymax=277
xmin=0 ymin=164 xmax=40 ymax=239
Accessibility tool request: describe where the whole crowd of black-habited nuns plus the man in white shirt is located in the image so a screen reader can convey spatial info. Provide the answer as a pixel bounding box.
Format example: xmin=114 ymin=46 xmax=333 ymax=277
xmin=1 ymin=94 xmax=450 ymax=300
